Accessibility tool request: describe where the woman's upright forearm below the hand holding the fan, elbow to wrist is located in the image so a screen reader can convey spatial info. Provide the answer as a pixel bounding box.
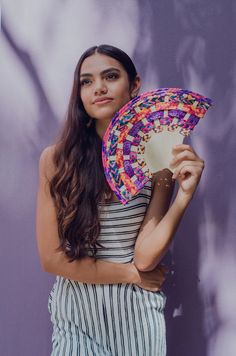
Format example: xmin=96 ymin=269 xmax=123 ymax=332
xmin=134 ymin=192 xmax=191 ymax=272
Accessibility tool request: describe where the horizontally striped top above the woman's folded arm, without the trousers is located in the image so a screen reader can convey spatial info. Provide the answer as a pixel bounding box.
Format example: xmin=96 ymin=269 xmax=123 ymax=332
xmin=89 ymin=180 xmax=152 ymax=263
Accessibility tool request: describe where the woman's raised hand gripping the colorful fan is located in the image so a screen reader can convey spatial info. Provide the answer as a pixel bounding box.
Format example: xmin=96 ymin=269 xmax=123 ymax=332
xmin=170 ymin=144 xmax=205 ymax=197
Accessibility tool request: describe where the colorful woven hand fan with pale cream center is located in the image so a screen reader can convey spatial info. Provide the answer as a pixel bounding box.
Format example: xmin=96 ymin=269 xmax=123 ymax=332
xmin=102 ymin=88 xmax=212 ymax=204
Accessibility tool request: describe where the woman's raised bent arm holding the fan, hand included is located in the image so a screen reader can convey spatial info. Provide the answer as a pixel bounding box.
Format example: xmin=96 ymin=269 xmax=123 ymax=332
xmin=134 ymin=144 xmax=204 ymax=271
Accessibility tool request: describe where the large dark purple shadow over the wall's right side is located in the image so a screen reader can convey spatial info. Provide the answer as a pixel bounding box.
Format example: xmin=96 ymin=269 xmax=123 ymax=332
xmin=135 ymin=0 xmax=236 ymax=356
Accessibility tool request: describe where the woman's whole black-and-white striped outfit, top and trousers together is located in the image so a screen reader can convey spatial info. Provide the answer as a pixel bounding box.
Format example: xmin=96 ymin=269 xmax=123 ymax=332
xmin=48 ymin=180 xmax=166 ymax=356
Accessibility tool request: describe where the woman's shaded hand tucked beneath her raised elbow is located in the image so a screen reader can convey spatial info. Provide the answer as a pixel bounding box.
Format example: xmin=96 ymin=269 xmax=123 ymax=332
xmin=131 ymin=262 xmax=169 ymax=292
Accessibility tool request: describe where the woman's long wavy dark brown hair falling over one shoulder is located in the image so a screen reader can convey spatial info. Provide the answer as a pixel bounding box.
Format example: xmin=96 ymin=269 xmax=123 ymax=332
xmin=49 ymin=45 xmax=137 ymax=262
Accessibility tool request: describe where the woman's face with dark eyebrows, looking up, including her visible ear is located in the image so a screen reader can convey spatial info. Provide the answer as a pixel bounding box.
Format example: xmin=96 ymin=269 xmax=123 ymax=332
xmin=80 ymin=53 xmax=140 ymax=121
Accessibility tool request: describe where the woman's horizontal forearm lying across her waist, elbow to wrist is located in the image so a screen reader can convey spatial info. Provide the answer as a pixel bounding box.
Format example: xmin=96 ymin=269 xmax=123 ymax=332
xmin=44 ymin=252 xmax=138 ymax=284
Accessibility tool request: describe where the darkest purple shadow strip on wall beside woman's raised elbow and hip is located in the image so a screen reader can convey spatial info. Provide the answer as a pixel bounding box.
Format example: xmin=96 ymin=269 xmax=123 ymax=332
xmin=163 ymin=135 xmax=207 ymax=356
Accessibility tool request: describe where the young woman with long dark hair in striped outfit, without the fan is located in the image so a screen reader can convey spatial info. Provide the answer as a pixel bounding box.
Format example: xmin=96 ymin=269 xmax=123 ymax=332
xmin=36 ymin=45 xmax=204 ymax=356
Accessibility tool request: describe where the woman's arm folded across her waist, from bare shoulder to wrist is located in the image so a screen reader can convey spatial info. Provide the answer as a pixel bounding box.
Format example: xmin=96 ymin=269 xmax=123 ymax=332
xmin=36 ymin=146 xmax=140 ymax=284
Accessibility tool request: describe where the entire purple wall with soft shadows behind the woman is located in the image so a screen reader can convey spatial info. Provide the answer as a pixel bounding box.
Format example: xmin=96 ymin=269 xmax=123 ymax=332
xmin=0 ymin=0 xmax=236 ymax=356
